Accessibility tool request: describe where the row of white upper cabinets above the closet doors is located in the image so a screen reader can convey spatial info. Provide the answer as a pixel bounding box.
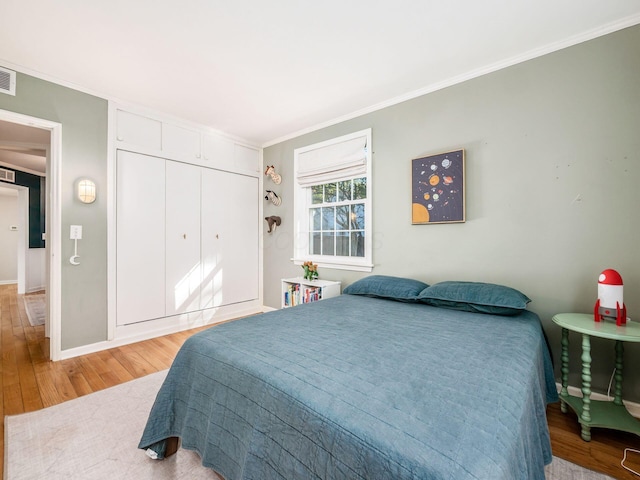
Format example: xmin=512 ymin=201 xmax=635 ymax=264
xmin=115 ymin=108 xmax=261 ymax=177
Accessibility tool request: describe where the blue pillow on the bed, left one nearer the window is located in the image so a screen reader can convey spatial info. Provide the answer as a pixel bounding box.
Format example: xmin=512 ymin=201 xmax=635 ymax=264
xmin=342 ymin=275 xmax=429 ymax=302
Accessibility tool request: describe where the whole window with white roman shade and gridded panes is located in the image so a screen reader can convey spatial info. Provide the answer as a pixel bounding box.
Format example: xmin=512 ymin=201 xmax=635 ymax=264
xmin=294 ymin=129 xmax=373 ymax=271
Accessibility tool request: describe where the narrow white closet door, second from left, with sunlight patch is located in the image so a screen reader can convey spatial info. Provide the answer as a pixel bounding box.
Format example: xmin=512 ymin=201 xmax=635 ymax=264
xmin=166 ymin=160 xmax=202 ymax=316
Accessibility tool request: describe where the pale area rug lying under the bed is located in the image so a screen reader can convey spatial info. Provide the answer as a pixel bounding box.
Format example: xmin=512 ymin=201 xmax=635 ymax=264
xmin=4 ymin=370 xmax=610 ymax=480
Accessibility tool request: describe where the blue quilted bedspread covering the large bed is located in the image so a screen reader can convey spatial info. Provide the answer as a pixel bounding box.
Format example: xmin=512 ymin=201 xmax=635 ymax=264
xmin=139 ymin=295 xmax=557 ymax=480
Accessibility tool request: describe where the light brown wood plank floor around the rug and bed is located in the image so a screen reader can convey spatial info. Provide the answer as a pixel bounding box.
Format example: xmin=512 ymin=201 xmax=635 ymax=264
xmin=0 ymin=285 xmax=640 ymax=480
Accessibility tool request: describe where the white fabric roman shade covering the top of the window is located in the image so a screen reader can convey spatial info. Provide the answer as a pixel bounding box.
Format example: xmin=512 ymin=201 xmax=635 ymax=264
xmin=296 ymin=131 xmax=368 ymax=187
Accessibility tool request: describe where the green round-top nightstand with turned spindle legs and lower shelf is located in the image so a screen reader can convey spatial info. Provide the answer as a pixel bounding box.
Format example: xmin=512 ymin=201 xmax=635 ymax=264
xmin=553 ymin=313 xmax=640 ymax=442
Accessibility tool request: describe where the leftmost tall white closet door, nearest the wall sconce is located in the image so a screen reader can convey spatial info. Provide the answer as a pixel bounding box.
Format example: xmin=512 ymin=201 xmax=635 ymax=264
xmin=116 ymin=150 xmax=165 ymax=325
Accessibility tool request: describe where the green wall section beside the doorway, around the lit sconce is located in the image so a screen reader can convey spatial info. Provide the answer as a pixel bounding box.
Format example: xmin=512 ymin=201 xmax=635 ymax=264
xmin=0 ymin=73 xmax=107 ymax=350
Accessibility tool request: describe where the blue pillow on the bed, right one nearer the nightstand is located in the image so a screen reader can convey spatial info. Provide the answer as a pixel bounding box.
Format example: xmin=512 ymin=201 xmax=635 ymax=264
xmin=418 ymin=282 xmax=531 ymax=315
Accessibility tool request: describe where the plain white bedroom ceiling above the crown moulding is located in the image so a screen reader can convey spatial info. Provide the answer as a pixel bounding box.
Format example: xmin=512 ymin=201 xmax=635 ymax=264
xmin=0 ymin=0 xmax=640 ymax=145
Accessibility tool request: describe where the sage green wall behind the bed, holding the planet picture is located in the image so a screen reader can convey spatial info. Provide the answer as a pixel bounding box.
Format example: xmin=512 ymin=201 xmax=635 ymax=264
xmin=264 ymin=26 xmax=640 ymax=401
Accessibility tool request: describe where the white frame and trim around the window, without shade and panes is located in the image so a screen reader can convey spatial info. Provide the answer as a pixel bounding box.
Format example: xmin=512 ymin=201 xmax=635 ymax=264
xmin=292 ymin=128 xmax=373 ymax=272
